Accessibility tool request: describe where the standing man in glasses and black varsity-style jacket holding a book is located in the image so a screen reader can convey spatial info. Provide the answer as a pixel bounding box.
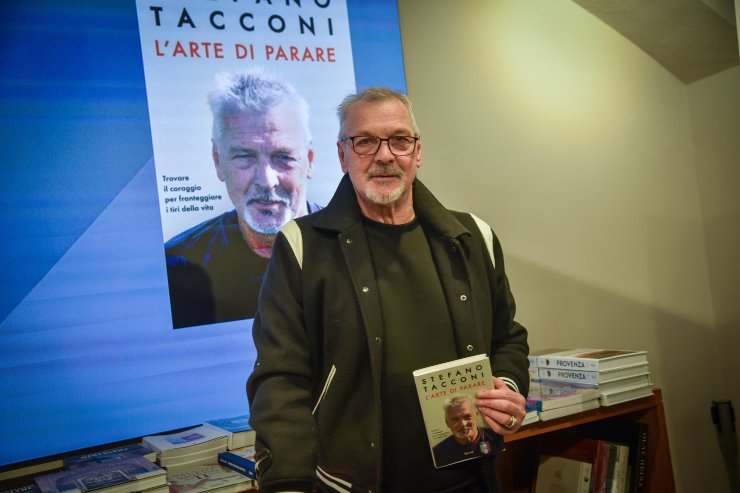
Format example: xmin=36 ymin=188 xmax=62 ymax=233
xmin=247 ymin=88 xmax=529 ymax=493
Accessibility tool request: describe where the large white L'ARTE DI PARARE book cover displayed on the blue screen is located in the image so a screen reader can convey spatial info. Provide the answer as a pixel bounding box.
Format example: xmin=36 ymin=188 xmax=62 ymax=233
xmin=137 ymin=0 xmax=355 ymax=328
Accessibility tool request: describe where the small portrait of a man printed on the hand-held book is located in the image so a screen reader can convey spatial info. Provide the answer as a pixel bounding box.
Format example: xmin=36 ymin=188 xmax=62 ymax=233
xmin=433 ymin=395 xmax=492 ymax=466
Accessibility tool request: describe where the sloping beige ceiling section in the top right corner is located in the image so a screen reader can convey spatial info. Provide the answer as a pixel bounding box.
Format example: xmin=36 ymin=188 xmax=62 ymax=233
xmin=573 ymin=0 xmax=740 ymax=84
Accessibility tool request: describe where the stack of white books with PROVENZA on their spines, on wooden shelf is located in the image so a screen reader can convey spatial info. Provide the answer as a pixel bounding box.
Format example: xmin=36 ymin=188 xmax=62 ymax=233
xmin=530 ymin=348 xmax=653 ymax=406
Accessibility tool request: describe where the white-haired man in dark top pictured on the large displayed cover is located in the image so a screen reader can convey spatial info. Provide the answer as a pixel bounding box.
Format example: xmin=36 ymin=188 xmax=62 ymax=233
xmin=165 ymin=71 xmax=319 ymax=328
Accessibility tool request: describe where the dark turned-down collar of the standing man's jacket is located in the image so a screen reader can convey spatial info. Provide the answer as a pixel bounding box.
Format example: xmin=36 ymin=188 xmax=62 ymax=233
xmin=314 ymin=173 xmax=470 ymax=238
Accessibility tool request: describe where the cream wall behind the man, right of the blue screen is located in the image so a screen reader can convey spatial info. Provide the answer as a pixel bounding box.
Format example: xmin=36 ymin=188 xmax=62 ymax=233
xmin=399 ymin=0 xmax=738 ymax=492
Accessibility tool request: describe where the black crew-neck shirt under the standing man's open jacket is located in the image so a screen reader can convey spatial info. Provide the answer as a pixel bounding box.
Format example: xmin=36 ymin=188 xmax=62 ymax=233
xmin=365 ymin=219 xmax=481 ymax=492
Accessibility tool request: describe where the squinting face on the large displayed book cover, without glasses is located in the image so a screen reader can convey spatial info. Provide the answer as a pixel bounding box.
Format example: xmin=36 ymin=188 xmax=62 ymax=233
xmin=213 ymin=102 xmax=313 ymax=235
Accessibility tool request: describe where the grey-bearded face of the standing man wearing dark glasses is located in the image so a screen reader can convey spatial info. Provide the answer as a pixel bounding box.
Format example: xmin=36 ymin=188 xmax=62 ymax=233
xmin=337 ymin=99 xmax=421 ymax=211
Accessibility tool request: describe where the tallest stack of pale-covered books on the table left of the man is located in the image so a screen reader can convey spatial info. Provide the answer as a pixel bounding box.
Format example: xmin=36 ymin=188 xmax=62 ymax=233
xmin=142 ymin=425 xmax=229 ymax=473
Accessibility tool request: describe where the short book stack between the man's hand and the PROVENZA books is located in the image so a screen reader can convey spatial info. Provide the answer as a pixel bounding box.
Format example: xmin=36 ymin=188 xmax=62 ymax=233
xmin=526 ymin=382 xmax=601 ymax=421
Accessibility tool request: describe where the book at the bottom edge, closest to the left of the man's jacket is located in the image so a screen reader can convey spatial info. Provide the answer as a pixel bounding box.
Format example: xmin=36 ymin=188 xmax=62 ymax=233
xmin=168 ymin=464 xmax=253 ymax=493
